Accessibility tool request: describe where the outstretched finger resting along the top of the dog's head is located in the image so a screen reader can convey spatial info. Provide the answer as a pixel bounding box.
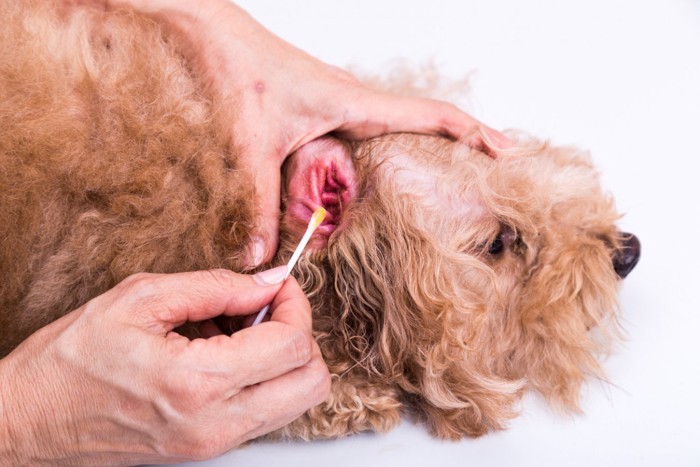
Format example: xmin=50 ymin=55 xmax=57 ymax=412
xmin=330 ymin=90 xmax=512 ymax=154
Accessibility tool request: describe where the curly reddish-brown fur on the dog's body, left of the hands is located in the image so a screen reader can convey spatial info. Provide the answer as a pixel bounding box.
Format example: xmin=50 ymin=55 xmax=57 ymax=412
xmin=0 ymin=1 xmax=252 ymax=354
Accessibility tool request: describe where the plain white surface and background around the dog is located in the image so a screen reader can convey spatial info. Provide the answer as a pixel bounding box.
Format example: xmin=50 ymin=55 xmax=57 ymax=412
xmin=183 ymin=0 xmax=700 ymax=467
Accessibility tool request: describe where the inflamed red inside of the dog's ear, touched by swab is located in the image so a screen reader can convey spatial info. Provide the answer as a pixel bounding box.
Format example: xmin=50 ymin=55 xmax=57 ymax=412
xmin=283 ymin=137 xmax=358 ymax=248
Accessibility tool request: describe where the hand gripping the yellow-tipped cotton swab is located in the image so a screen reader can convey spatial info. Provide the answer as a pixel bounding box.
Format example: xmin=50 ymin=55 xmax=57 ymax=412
xmin=0 ymin=268 xmax=330 ymax=465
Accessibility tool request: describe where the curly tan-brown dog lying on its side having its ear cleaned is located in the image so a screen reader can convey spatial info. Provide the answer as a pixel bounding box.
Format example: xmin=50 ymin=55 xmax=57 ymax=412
xmin=0 ymin=0 xmax=640 ymax=439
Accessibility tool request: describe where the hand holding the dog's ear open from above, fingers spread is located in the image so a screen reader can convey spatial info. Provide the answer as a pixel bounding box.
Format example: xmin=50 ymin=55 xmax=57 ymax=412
xmin=108 ymin=0 xmax=509 ymax=265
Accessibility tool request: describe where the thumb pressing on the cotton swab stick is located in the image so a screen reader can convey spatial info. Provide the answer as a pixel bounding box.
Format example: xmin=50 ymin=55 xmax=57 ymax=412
xmin=121 ymin=266 xmax=287 ymax=334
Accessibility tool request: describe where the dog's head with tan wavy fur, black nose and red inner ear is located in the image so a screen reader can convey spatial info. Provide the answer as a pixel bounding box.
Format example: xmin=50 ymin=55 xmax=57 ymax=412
xmin=282 ymin=135 xmax=639 ymax=437
